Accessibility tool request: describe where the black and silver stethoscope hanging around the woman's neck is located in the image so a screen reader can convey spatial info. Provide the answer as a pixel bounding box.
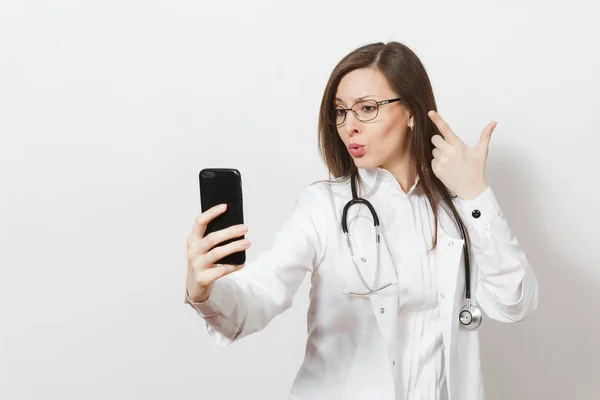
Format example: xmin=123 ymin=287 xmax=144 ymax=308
xmin=342 ymin=174 xmax=483 ymax=330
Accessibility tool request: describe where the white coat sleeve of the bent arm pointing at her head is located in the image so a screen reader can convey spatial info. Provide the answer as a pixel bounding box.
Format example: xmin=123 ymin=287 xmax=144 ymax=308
xmin=455 ymin=186 xmax=538 ymax=322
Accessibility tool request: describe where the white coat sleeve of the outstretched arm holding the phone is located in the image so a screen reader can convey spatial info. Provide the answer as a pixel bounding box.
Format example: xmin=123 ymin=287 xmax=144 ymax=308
xmin=185 ymin=185 xmax=327 ymax=346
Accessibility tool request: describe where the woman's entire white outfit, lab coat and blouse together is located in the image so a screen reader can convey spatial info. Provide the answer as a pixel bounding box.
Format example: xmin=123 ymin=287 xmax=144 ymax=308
xmin=184 ymin=168 xmax=537 ymax=400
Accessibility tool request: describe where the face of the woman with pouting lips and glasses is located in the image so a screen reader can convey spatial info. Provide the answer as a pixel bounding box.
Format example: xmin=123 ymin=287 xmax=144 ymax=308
xmin=334 ymin=68 xmax=412 ymax=170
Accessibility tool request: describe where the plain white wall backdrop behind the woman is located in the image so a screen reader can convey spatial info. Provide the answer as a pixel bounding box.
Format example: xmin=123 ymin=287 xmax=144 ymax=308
xmin=0 ymin=0 xmax=600 ymax=400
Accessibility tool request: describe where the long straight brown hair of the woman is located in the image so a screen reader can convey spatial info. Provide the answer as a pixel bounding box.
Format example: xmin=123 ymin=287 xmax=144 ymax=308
xmin=319 ymin=42 xmax=469 ymax=249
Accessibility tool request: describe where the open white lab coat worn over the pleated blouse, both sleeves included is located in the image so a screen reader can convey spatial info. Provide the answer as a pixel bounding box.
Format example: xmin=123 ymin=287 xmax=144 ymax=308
xmin=186 ymin=168 xmax=538 ymax=400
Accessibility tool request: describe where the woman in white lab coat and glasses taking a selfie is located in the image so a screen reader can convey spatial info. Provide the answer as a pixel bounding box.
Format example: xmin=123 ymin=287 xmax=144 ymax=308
xmin=186 ymin=42 xmax=538 ymax=400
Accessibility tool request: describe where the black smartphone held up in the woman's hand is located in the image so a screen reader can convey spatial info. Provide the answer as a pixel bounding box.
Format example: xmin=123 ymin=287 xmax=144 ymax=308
xmin=199 ymin=168 xmax=246 ymax=265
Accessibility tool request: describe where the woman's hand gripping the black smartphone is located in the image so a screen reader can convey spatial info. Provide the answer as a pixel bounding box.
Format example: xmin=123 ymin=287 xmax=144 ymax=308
xmin=186 ymin=204 xmax=251 ymax=303
